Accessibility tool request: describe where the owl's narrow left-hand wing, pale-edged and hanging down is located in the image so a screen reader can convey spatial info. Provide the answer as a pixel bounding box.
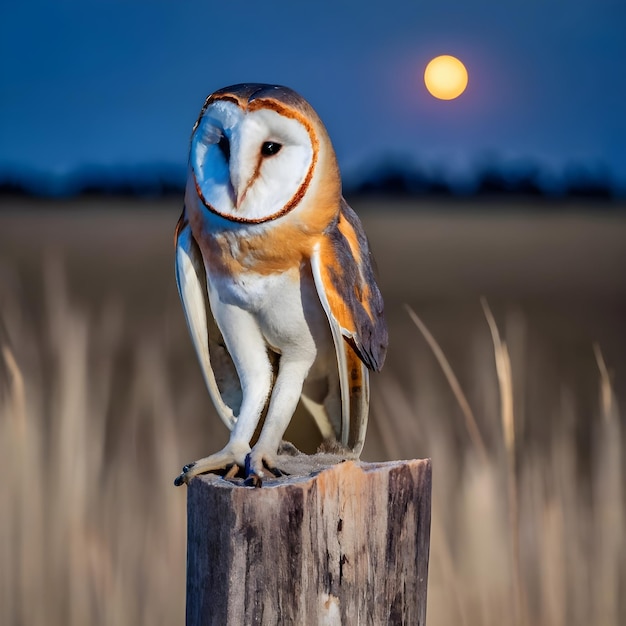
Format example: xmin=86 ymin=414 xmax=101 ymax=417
xmin=175 ymin=209 xmax=242 ymax=430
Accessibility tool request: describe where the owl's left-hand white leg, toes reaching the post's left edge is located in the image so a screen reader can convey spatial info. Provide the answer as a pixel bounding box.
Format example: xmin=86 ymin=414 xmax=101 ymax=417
xmin=174 ymin=305 xmax=272 ymax=486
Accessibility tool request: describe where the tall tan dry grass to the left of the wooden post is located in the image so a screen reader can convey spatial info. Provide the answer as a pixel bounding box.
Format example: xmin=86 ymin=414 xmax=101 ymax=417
xmin=0 ymin=264 xmax=186 ymax=626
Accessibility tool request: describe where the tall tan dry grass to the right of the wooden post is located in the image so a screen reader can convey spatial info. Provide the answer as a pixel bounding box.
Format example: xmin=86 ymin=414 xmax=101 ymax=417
xmin=383 ymin=301 xmax=626 ymax=626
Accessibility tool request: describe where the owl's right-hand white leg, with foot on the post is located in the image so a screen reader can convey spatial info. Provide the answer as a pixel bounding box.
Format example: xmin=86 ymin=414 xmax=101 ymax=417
xmin=246 ymin=350 xmax=315 ymax=486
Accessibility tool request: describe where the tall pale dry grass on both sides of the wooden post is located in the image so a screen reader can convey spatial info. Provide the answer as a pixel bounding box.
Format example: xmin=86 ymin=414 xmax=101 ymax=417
xmin=0 ymin=271 xmax=626 ymax=626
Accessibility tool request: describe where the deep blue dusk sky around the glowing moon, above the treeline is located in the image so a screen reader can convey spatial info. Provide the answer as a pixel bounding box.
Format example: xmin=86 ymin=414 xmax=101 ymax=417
xmin=0 ymin=0 xmax=626 ymax=192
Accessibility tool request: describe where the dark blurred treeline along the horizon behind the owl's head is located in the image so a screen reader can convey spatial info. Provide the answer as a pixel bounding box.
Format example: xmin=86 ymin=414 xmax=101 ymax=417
xmin=0 ymin=162 xmax=624 ymax=202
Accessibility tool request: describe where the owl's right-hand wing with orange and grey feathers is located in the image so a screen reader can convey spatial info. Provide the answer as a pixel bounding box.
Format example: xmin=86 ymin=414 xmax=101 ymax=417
xmin=311 ymin=198 xmax=388 ymax=455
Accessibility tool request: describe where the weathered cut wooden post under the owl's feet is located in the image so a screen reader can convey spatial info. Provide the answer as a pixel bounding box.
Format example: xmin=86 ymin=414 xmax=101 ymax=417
xmin=187 ymin=454 xmax=431 ymax=626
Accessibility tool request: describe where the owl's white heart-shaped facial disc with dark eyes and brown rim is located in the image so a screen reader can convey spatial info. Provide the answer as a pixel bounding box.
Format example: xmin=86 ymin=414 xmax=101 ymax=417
xmin=190 ymin=100 xmax=316 ymax=222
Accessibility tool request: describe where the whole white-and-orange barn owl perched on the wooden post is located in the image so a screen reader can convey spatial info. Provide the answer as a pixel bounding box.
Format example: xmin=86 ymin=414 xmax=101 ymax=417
xmin=175 ymin=84 xmax=387 ymax=485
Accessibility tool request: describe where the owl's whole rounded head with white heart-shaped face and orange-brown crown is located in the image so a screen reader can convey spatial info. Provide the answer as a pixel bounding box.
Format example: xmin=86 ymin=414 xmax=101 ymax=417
xmin=189 ymin=84 xmax=341 ymax=223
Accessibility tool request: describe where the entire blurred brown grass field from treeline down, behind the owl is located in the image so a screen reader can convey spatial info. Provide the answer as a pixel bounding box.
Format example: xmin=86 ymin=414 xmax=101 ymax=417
xmin=0 ymin=198 xmax=626 ymax=626
